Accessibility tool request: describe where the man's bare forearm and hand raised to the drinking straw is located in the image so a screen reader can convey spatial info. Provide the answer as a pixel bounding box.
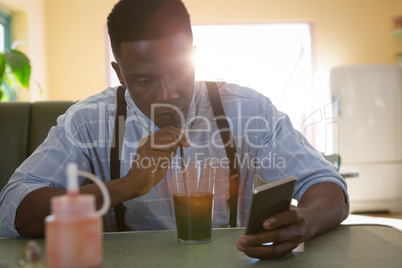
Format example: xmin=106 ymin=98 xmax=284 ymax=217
xmin=15 ymin=127 xmax=190 ymax=237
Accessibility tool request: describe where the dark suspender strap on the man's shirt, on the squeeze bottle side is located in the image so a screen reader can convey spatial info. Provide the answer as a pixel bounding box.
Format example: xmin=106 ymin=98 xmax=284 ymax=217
xmin=110 ymin=86 xmax=127 ymax=232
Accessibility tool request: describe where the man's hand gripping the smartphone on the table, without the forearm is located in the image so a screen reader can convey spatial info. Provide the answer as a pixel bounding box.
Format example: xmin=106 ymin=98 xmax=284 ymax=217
xmin=237 ymin=206 xmax=307 ymax=260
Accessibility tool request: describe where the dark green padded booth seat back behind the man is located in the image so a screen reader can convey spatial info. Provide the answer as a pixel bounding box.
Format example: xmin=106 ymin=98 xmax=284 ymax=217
xmin=0 ymin=101 xmax=74 ymax=190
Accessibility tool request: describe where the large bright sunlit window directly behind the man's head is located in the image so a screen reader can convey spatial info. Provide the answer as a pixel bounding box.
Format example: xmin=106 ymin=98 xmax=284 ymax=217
xmin=109 ymin=23 xmax=313 ymax=140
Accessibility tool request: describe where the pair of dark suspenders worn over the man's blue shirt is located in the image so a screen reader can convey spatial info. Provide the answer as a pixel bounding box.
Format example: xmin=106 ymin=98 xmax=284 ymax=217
xmin=110 ymin=82 xmax=239 ymax=231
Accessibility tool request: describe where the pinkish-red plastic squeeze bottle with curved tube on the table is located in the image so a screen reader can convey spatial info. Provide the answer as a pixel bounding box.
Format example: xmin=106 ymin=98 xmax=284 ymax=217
xmin=45 ymin=163 xmax=110 ymax=268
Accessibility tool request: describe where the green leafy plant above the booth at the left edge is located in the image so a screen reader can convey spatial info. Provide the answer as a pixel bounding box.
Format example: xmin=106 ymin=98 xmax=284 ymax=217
xmin=0 ymin=49 xmax=31 ymax=101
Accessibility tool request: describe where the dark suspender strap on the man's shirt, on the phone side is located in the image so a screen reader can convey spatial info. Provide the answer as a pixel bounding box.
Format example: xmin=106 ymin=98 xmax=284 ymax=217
xmin=205 ymin=82 xmax=239 ymax=227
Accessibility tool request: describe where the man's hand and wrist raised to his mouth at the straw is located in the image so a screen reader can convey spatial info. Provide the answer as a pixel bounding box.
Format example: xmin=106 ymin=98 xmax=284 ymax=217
xmin=124 ymin=126 xmax=190 ymax=198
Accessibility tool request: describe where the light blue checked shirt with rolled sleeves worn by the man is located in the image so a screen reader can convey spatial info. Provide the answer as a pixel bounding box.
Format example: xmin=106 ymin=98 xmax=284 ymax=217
xmin=0 ymin=81 xmax=349 ymax=237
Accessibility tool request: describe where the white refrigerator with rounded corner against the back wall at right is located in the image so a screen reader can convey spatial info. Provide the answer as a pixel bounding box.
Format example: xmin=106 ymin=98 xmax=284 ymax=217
xmin=330 ymin=64 xmax=402 ymax=212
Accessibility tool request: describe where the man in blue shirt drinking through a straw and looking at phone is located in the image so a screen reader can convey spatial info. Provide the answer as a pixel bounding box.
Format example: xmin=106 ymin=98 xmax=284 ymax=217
xmin=0 ymin=0 xmax=348 ymax=259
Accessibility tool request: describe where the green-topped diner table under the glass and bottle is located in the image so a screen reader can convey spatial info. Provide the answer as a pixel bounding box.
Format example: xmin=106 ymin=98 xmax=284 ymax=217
xmin=0 ymin=225 xmax=402 ymax=268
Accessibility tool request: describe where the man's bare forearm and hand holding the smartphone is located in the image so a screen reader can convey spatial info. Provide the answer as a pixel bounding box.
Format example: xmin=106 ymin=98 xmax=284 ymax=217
xmin=237 ymin=182 xmax=349 ymax=260
